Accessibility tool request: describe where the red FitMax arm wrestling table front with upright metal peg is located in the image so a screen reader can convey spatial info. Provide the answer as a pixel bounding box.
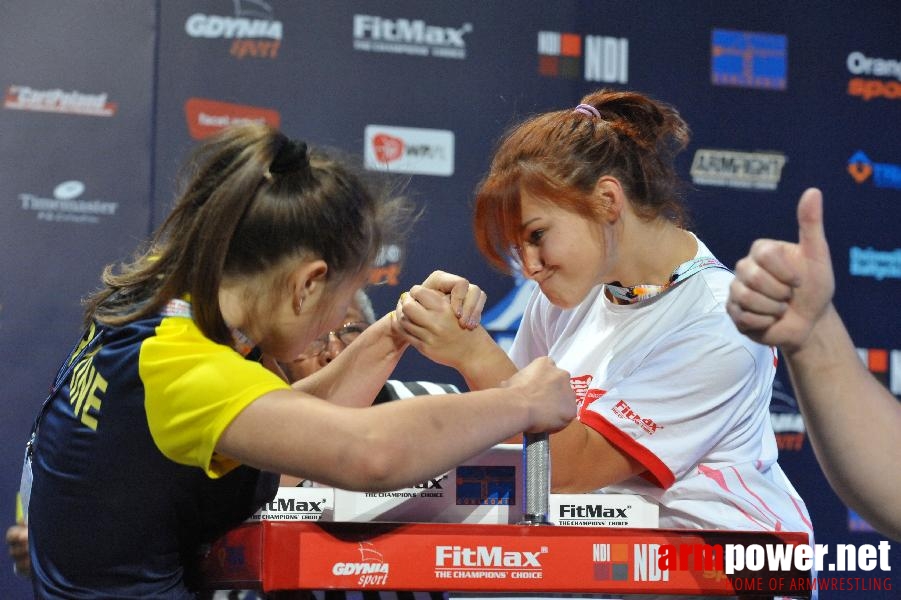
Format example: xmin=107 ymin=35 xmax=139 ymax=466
xmin=201 ymin=436 xmax=811 ymax=598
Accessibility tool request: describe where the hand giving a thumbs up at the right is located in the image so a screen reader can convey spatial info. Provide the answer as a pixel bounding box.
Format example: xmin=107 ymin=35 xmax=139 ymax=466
xmin=726 ymin=188 xmax=835 ymax=353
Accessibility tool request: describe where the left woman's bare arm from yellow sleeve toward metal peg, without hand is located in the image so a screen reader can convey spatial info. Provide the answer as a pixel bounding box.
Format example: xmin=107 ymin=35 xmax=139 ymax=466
xmin=217 ymin=388 xmax=530 ymax=491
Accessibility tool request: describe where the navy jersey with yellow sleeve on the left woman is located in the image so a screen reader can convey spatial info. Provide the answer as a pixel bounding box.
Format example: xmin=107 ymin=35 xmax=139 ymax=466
xmin=28 ymin=301 xmax=288 ymax=599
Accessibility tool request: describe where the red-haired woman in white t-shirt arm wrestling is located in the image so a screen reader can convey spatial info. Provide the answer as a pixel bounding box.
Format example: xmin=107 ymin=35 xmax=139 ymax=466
xmin=398 ymin=90 xmax=811 ymax=532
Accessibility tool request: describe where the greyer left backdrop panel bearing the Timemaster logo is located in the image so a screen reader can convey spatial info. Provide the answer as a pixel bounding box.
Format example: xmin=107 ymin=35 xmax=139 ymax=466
xmin=0 ymin=0 xmax=158 ymax=599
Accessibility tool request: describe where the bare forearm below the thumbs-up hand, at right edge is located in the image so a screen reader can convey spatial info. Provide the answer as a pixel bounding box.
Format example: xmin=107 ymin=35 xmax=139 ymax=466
xmin=785 ymin=306 xmax=901 ymax=538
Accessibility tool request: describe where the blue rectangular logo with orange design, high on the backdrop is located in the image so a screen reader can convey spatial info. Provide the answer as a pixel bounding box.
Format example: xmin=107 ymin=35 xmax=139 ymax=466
xmin=710 ymin=29 xmax=788 ymax=90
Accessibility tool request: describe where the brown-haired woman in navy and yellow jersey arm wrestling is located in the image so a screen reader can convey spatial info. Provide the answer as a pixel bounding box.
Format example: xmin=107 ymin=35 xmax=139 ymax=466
xmin=28 ymin=125 xmax=575 ymax=600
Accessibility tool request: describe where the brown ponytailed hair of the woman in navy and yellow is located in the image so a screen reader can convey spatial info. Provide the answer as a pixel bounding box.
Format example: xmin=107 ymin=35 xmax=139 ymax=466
xmin=85 ymin=124 xmax=411 ymax=343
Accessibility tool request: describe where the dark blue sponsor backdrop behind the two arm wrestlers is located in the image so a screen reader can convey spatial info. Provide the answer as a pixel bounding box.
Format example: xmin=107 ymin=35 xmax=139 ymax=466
xmin=0 ymin=0 xmax=901 ymax=598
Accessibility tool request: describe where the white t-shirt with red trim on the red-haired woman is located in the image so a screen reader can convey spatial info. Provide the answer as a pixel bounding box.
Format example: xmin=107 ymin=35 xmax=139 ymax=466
xmin=510 ymin=240 xmax=812 ymax=537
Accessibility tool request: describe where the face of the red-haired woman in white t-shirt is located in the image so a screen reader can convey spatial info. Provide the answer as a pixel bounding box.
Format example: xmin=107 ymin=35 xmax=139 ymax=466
xmin=520 ymin=193 xmax=609 ymax=308
